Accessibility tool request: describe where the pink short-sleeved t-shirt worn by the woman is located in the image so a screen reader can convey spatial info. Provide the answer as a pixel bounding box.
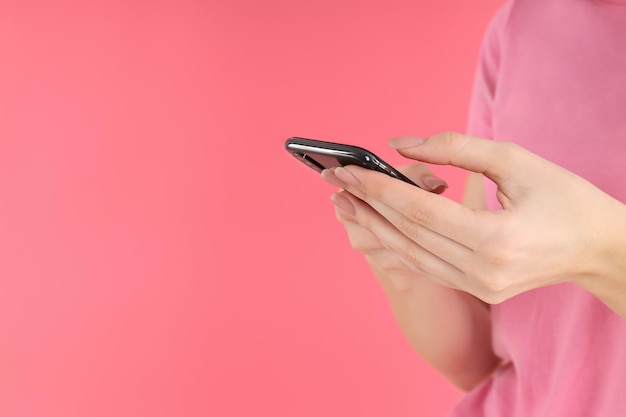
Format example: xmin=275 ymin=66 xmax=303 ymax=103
xmin=451 ymin=0 xmax=626 ymax=417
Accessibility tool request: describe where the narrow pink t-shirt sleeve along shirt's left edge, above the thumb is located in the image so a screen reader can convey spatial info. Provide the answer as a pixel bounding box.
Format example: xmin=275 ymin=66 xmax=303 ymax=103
xmin=467 ymin=1 xmax=512 ymax=139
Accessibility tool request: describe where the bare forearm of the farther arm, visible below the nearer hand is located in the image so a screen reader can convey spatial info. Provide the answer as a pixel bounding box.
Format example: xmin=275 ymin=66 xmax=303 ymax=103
xmin=372 ymin=267 xmax=500 ymax=390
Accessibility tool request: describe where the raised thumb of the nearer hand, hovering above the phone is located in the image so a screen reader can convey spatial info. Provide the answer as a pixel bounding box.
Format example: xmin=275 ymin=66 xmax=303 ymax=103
xmin=389 ymin=132 xmax=532 ymax=182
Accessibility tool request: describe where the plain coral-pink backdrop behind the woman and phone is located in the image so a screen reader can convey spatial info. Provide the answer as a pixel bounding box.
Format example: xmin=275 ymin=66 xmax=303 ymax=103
xmin=0 ymin=0 xmax=501 ymax=417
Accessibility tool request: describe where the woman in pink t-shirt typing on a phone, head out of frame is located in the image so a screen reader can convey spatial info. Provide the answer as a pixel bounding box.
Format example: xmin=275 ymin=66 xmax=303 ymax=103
xmin=322 ymin=0 xmax=626 ymax=417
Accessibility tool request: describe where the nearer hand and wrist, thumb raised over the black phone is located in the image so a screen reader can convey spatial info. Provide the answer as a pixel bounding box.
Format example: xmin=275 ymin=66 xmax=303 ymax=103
xmin=326 ymin=133 xmax=626 ymax=308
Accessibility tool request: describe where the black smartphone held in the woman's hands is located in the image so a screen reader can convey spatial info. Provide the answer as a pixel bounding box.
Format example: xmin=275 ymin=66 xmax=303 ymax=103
xmin=285 ymin=137 xmax=421 ymax=188
